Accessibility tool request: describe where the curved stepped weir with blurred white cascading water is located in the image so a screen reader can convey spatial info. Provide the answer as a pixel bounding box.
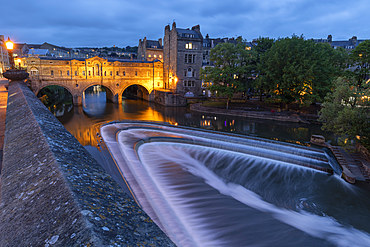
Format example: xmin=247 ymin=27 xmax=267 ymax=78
xmin=101 ymin=122 xmax=370 ymax=246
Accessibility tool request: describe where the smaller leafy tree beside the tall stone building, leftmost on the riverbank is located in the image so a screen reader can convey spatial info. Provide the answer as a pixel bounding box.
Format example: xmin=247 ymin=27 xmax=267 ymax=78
xmin=201 ymin=37 xmax=254 ymax=109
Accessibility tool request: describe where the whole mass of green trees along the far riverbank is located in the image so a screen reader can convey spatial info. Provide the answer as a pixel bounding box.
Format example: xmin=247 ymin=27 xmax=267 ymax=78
xmin=202 ymin=38 xmax=370 ymax=149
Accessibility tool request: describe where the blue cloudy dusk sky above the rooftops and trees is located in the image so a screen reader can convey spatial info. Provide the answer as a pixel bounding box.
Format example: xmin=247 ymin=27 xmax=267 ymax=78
xmin=0 ymin=0 xmax=370 ymax=47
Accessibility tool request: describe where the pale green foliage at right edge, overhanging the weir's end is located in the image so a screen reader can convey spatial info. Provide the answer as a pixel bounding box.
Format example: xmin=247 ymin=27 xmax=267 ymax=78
xmin=319 ymin=78 xmax=370 ymax=148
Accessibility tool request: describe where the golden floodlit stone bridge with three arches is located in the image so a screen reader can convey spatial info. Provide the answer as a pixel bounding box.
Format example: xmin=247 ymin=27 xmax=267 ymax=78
xmin=23 ymin=57 xmax=168 ymax=105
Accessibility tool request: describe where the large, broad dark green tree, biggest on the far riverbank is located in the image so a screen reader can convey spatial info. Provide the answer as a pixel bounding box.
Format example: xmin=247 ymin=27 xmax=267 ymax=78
xmin=259 ymin=36 xmax=344 ymax=104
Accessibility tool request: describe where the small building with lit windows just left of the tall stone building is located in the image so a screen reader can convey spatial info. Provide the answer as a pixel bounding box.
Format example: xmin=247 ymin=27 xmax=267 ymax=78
xmin=137 ymin=37 xmax=163 ymax=62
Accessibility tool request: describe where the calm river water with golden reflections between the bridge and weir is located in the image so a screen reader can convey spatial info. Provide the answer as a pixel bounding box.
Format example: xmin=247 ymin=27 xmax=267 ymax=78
xmin=58 ymin=92 xmax=334 ymax=146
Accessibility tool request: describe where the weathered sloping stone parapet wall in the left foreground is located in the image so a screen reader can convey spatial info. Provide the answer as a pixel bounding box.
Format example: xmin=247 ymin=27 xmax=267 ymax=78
xmin=0 ymin=82 xmax=173 ymax=246
